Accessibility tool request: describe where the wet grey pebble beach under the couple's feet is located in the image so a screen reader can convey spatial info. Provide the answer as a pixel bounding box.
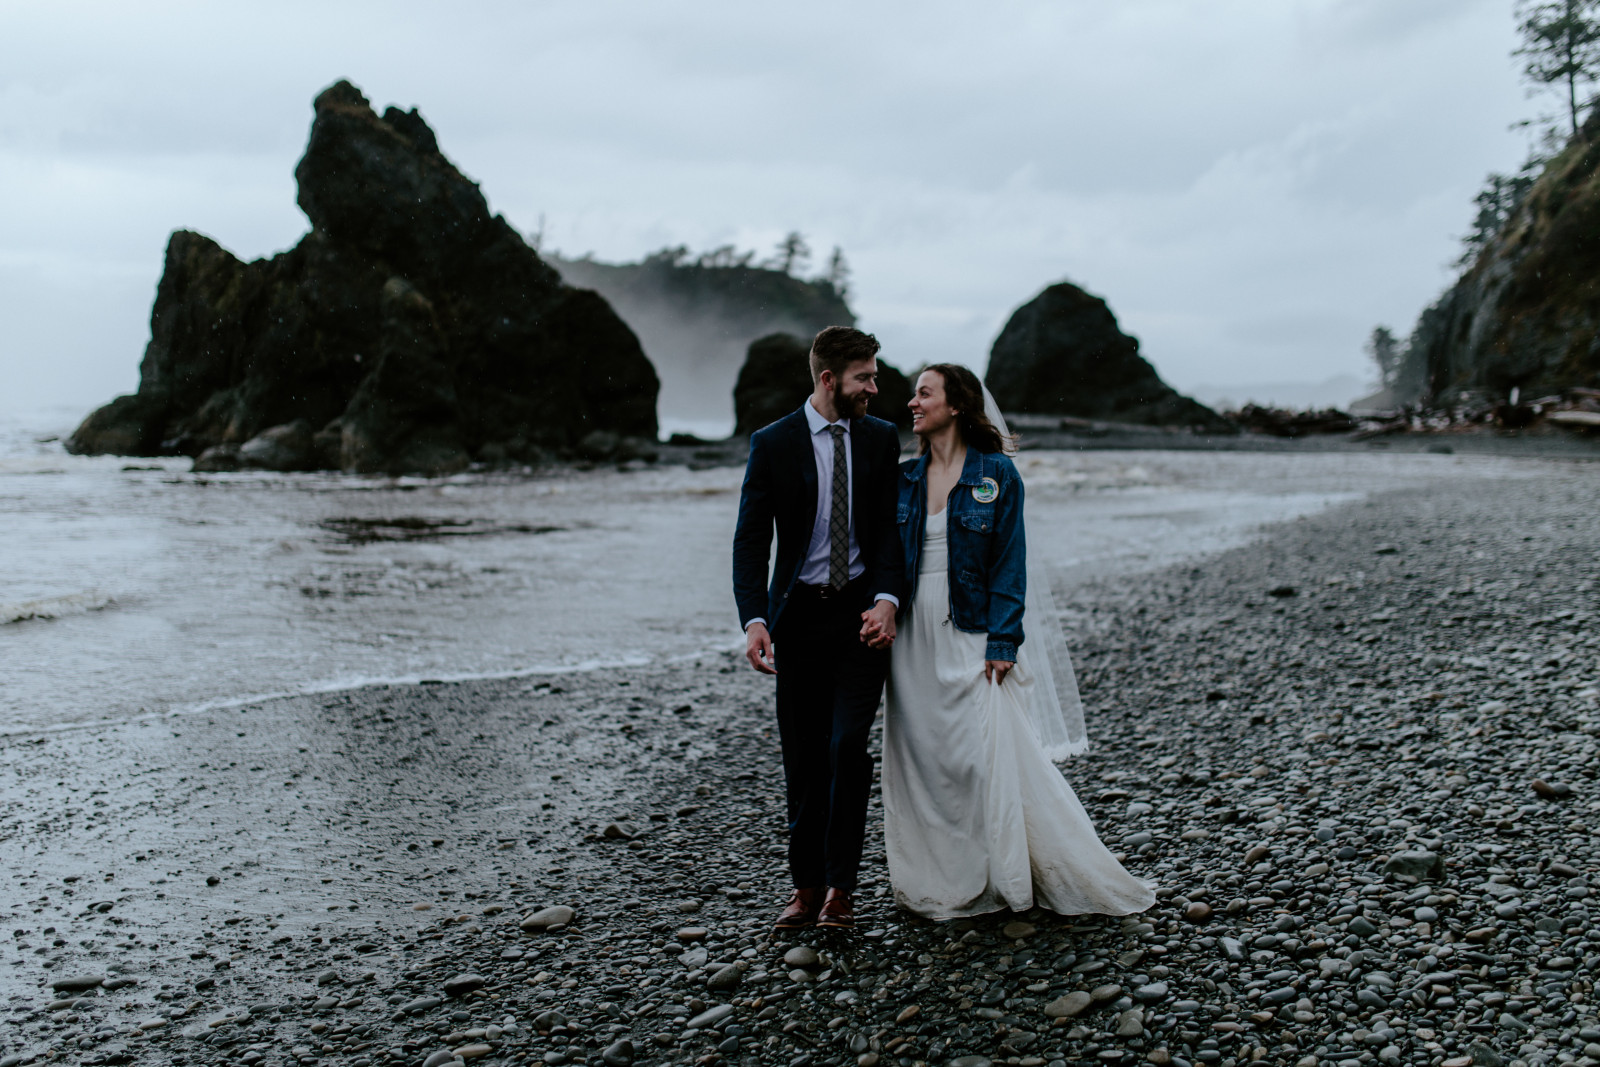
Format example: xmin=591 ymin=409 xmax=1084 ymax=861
xmin=0 ymin=459 xmax=1600 ymax=1067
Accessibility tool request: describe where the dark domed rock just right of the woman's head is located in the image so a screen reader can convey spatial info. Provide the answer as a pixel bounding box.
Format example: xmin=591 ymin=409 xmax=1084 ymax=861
xmin=984 ymin=282 xmax=1237 ymax=434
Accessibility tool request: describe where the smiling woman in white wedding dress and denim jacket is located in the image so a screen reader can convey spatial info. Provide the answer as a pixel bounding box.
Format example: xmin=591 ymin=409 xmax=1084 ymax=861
xmin=883 ymin=363 xmax=1155 ymax=918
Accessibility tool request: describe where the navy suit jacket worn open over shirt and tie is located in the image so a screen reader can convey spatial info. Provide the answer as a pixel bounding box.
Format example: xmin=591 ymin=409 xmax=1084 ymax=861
xmin=733 ymin=402 xmax=906 ymax=638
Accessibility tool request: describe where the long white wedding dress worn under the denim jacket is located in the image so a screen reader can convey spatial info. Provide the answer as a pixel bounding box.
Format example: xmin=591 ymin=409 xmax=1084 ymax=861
xmin=883 ymin=509 xmax=1155 ymax=918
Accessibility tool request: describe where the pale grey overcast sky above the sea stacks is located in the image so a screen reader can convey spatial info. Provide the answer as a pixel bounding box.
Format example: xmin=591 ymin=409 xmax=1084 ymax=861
xmin=0 ymin=0 xmax=1544 ymax=408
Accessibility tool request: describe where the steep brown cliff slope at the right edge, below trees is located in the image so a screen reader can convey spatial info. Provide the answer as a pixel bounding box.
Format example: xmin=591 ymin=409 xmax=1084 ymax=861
xmin=1400 ymin=109 xmax=1600 ymax=406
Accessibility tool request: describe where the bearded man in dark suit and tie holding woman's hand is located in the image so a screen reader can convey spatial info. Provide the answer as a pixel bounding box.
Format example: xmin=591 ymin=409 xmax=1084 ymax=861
xmin=733 ymin=326 xmax=904 ymax=929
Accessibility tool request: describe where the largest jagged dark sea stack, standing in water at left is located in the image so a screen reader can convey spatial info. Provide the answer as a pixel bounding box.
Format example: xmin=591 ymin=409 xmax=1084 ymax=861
xmin=67 ymin=82 xmax=658 ymax=472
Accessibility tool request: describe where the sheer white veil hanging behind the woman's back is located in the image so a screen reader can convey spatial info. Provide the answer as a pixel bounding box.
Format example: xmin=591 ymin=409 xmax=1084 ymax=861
xmin=984 ymin=386 xmax=1090 ymax=760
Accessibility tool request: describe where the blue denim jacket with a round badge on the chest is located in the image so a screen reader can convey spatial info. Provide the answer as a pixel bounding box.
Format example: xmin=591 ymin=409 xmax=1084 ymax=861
xmin=896 ymin=446 xmax=1027 ymax=662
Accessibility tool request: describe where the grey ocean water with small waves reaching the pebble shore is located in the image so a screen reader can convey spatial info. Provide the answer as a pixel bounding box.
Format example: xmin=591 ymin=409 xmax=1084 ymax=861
xmin=0 ymin=404 xmax=1531 ymax=733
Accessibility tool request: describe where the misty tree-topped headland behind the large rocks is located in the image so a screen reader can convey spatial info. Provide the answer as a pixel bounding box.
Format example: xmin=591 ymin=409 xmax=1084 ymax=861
xmin=550 ymin=248 xmax=856 ymax=435
